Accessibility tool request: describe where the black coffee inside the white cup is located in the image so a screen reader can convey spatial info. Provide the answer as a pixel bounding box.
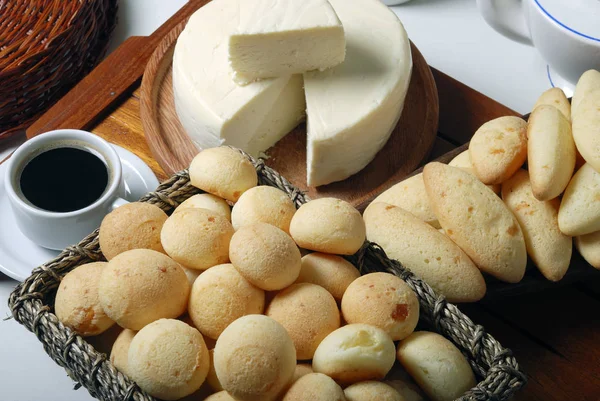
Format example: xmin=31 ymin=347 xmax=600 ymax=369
xmin=19 ymin=147 xmax=108 ymax=212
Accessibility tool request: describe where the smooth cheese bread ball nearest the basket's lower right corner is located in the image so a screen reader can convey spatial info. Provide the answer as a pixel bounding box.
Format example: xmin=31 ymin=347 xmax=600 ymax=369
xmin=397 ymin=331 xmax=475 ymax=401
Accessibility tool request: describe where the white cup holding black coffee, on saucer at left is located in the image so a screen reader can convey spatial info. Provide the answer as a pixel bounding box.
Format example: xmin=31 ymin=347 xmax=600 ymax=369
xmin=4 ymin=129 xmax=127 ymax=250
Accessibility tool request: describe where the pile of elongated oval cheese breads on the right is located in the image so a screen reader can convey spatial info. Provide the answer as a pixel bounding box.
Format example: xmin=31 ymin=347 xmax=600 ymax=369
xmin=364 ymin=70 xmax=600 ymax=302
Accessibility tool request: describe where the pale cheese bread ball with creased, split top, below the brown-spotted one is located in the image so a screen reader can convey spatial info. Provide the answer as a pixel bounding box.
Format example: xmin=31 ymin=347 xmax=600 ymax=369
xmin=312 ymin=324 xmax=395 ymax=384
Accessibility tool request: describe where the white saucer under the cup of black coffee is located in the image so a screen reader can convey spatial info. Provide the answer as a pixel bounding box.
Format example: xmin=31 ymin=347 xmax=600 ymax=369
xmin=0 ymin=145 xmax=159 ymax=281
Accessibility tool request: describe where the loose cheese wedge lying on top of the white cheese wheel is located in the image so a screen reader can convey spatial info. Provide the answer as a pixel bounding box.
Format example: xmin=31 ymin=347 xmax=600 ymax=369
xmin=229 ymin=0 xmax=346 ymax=85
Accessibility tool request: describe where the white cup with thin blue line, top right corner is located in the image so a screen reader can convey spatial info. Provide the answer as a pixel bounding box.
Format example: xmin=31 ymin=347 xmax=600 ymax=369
xmin=477 ymin=0 xmax=600 ymax=86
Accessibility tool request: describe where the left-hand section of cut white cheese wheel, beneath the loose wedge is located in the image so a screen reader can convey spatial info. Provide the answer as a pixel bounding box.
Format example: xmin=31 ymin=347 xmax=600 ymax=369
xmin=173 ymin=0 xmax=306 ymax=156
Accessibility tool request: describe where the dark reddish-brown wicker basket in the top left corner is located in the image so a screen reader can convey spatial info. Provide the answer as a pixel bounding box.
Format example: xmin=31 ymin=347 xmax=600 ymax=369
xmin=0 ymin=0 xmax=118 ymax=139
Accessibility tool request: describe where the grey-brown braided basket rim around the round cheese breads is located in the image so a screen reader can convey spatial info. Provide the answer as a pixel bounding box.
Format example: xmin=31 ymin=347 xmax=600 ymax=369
xmin=9 ymin=150 xmax=527 ymax=401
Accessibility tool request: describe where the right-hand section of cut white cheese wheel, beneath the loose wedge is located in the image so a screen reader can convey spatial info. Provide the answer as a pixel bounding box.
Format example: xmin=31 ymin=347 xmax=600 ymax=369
xmin=304 ymin=0 xmax=412 ymax=186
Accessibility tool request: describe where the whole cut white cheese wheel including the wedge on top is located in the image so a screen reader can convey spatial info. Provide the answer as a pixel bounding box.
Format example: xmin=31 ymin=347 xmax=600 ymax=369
xmin=173 ymin=0 xmax=412 ymax=186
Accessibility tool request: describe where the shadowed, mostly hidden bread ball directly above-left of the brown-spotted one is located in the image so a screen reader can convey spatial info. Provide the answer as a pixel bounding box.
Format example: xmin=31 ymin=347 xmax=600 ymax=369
xmin=296 ymin=252 xmax=360 ymax=302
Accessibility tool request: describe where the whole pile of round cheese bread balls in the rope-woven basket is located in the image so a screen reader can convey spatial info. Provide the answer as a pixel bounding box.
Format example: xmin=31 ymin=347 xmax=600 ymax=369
xmin=55 ymin=147 xmax=476 ymax=401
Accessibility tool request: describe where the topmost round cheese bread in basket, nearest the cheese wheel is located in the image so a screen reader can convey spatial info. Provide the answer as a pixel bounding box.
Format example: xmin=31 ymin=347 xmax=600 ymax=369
xmin=189 ymin=146 xmax=258 ymax=202
